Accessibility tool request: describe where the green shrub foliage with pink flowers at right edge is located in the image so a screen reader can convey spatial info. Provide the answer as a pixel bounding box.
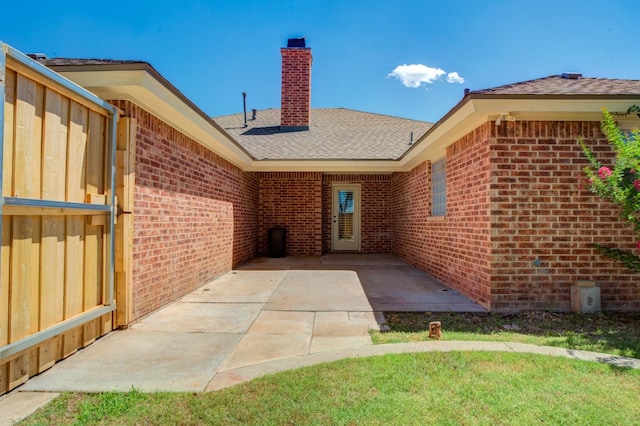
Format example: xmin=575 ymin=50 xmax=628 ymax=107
xmin=579 ymin=109 xmax=640 ymax=272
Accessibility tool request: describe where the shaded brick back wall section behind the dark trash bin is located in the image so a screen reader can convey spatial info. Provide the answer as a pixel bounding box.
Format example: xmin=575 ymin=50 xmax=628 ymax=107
xmin=258 ymin=172 xmax=322 ymax=256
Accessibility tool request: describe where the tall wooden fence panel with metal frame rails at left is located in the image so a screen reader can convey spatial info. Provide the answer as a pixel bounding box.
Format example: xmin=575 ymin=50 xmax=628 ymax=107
xmin=0 ymin=43 xmax=118 ymax=394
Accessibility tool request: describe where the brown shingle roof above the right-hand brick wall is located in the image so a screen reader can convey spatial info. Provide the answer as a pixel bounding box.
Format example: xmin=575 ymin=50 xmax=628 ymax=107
xmin=471 ymin=75 xmax=640 ymax=96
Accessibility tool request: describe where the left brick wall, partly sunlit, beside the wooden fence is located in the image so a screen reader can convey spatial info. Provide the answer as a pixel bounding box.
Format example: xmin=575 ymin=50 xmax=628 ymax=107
xmin=115 ymin=101 xmax=258 ymax=319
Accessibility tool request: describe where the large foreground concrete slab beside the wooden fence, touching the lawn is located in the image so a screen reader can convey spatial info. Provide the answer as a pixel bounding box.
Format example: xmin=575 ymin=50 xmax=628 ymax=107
xmin=21 ymin=330 xmax=242 ymax=392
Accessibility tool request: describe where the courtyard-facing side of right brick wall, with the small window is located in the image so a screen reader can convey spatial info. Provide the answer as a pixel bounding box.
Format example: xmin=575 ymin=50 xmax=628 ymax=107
xmin=392 ymin=126 xmax=491 ymax=308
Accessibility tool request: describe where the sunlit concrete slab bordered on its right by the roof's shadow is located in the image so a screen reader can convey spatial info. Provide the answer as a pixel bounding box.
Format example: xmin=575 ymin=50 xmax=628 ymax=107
xmin=264 ymin=270 xmax=373 ymax=312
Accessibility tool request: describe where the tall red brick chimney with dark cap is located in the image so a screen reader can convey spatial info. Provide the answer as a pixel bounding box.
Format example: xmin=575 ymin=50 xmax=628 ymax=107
xmin=280 ymin=38 xmax=312 ymax=131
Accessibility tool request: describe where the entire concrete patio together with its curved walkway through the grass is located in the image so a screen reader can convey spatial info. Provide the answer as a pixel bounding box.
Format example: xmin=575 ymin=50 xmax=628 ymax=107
xmin=0 ymin=255 xmax=640 ymax=424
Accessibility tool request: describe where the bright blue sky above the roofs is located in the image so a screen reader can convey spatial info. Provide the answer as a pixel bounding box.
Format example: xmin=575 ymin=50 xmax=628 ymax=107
xmin=0 ymin=0 xmax=640 ymax=122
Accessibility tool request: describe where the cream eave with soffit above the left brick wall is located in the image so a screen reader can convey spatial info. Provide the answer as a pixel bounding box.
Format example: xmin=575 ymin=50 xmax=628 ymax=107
xmin=54 ymin=70 xmax=252 ymax=169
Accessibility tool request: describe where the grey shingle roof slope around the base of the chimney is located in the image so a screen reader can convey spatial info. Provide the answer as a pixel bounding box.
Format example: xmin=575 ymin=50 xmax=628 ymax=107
xmin=213 ymin=108 xmax=433 ymax=160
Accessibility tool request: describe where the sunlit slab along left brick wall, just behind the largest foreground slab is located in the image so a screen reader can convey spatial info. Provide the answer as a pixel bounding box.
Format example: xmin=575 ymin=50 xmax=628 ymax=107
xmin=131 ymin=302 xmax=262 ymax=334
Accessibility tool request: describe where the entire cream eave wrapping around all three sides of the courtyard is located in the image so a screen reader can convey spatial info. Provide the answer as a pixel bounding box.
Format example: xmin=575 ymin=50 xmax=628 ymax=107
xmin=46 ymin=63 xmax=640 ymax=173
